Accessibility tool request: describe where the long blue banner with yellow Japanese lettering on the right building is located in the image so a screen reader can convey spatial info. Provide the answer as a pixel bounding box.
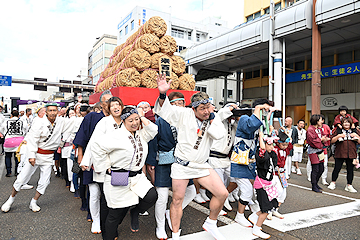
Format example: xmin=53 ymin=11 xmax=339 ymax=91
xmin=285 ymin=62 xmax=360 ymax=83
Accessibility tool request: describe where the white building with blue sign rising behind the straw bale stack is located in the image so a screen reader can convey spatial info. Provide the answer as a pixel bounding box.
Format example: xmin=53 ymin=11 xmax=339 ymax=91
xmin=117 ymin=6 xmax=236 ymax=107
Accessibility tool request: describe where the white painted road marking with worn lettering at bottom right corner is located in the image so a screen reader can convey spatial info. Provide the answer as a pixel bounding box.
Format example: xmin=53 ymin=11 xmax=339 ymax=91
xmin=264 ymin=201 xmax=360 ymax=232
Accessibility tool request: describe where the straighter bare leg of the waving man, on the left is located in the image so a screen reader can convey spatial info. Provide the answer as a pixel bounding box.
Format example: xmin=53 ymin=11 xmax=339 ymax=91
xmin=170 ymin=179 xmax=189 ymax=233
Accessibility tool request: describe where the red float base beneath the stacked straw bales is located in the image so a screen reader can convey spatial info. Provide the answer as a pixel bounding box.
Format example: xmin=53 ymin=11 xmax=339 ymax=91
xmin=89 ymin=87 xmax=198 ymax=106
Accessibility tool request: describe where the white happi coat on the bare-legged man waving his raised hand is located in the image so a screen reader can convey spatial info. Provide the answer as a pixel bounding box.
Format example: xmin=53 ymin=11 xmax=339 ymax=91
xmin=154 ymin=97 xmax=225 ymax=179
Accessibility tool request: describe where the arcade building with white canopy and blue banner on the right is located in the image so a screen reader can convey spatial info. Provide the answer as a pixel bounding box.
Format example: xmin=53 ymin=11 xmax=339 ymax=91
xmin=185 ymin=0 xmax=360 ymax=125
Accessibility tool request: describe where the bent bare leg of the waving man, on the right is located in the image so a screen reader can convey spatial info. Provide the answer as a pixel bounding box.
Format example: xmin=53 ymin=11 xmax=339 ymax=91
xmin=198 ymin=169 xmax=228 ymax=220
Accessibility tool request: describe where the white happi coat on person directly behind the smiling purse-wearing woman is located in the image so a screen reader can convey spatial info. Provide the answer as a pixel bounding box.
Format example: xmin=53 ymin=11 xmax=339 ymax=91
xmin=80 ymin=115 xmax=119 ymax=183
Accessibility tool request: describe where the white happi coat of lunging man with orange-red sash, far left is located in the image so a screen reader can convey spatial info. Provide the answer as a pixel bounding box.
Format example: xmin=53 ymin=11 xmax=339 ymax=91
xmin=26 ymin=117 xmax=74 ymax=165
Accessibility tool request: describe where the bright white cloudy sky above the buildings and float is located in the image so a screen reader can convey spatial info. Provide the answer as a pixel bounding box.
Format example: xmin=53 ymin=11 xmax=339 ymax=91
xmin=0 ymin=0 xmax=244 ymax=99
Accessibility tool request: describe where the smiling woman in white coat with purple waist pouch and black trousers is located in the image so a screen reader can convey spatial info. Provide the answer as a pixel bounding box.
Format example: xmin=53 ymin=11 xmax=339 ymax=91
xmin=91 ymin=107 xmax=157 ymax=240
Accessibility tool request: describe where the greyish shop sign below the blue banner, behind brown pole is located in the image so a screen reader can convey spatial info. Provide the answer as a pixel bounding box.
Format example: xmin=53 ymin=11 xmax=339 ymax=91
xmin=306 ymin=93 xmax=356 ymax=111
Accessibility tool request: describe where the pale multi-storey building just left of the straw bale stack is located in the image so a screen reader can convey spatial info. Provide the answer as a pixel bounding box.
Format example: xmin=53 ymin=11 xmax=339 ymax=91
xmin=87 ymin=34 xmax=117 ymax=84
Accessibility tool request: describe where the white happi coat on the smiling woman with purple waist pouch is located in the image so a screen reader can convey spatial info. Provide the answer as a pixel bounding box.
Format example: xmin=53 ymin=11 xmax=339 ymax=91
xmin=91 ymin=122 xmax=158 ymax=208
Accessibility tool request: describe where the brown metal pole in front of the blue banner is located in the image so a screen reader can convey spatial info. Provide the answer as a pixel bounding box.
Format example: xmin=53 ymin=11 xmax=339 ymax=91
xmin=311 ymin=0 xmax=321 ymax=114
